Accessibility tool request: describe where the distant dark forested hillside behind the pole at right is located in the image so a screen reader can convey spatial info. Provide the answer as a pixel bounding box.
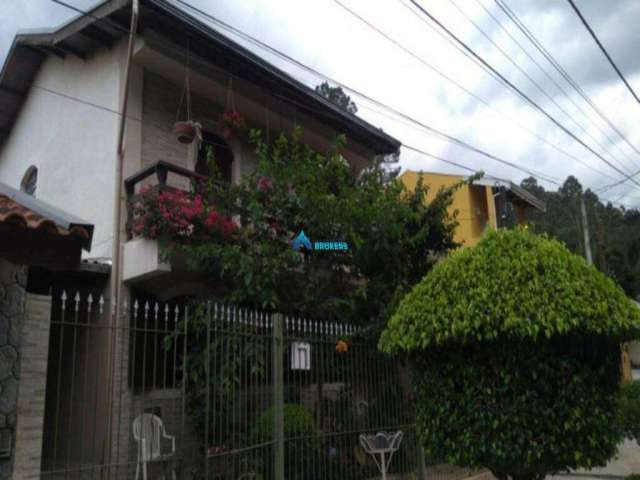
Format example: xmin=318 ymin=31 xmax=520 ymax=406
xmin=521 ymin=177 xmax=640 ymax=299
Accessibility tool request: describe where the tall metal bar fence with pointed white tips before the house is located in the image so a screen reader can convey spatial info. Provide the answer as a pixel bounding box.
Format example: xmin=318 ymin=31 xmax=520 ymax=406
xmin=37 ymin=292 xmax=472 ymax=480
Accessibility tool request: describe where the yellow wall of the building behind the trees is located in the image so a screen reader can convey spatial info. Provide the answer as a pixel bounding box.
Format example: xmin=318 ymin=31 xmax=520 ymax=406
xmin=400 ymin=171 xmax=497 ymax=246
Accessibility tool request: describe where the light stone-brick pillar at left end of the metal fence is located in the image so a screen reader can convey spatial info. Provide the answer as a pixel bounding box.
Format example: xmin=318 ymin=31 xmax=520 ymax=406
xmin=14 ymin=293 xmax=51 ymax=479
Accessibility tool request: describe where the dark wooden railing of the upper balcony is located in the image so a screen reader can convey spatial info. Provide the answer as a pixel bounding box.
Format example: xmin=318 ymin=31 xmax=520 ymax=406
xmin=124 ymin=160 xmax=208 ymax=239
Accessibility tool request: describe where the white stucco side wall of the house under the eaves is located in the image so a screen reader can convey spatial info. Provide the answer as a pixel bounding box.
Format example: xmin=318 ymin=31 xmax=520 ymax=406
xmin=0 ymin=46 xmax=122 ymax=257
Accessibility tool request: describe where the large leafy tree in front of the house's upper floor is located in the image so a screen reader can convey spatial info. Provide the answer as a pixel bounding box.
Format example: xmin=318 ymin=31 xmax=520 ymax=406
xmin=175 ymin=130 xmax=456 ymax=330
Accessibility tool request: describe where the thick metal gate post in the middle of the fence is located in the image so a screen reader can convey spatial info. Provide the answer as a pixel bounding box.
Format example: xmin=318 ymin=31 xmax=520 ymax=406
xmin=272 ymin=313 xmax=284 ymax=480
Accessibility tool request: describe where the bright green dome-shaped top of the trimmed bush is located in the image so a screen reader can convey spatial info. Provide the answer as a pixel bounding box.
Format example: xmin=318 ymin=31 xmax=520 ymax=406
xmin=381 ymin=229 xmax=640 ymax=352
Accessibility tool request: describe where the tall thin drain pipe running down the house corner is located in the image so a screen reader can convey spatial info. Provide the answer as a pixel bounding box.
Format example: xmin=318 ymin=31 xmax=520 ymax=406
xmin=105 ymin=0 xmax=140 ymax=464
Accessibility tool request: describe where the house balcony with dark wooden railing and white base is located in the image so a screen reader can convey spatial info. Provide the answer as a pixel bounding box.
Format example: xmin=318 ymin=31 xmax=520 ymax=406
xmin=122 ymin=160 xmax=207 ymax=290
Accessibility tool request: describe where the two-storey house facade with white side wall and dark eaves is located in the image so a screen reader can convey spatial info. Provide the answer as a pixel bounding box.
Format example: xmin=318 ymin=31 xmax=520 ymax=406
xmin=0 ymin=0 xmax=399 ymax=478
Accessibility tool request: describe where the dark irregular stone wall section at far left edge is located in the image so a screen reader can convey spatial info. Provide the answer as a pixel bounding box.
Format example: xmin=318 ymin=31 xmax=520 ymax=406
xmin=0 ymin=260 xmax=27 ymax=479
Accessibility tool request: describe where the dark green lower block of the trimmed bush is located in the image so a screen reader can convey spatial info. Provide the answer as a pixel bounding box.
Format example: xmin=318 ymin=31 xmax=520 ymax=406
xmin=415 ymin=335 xmax=621 ymax=479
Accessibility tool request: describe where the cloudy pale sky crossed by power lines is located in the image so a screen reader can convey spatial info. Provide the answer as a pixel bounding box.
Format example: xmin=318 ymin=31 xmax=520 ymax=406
xmin=0 ymin=0 xmax=640 ymax=207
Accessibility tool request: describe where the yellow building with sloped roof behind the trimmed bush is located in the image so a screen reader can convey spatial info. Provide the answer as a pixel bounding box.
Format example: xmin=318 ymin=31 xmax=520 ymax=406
xmin=400 ymin=170 xmax=545 ymax=246
